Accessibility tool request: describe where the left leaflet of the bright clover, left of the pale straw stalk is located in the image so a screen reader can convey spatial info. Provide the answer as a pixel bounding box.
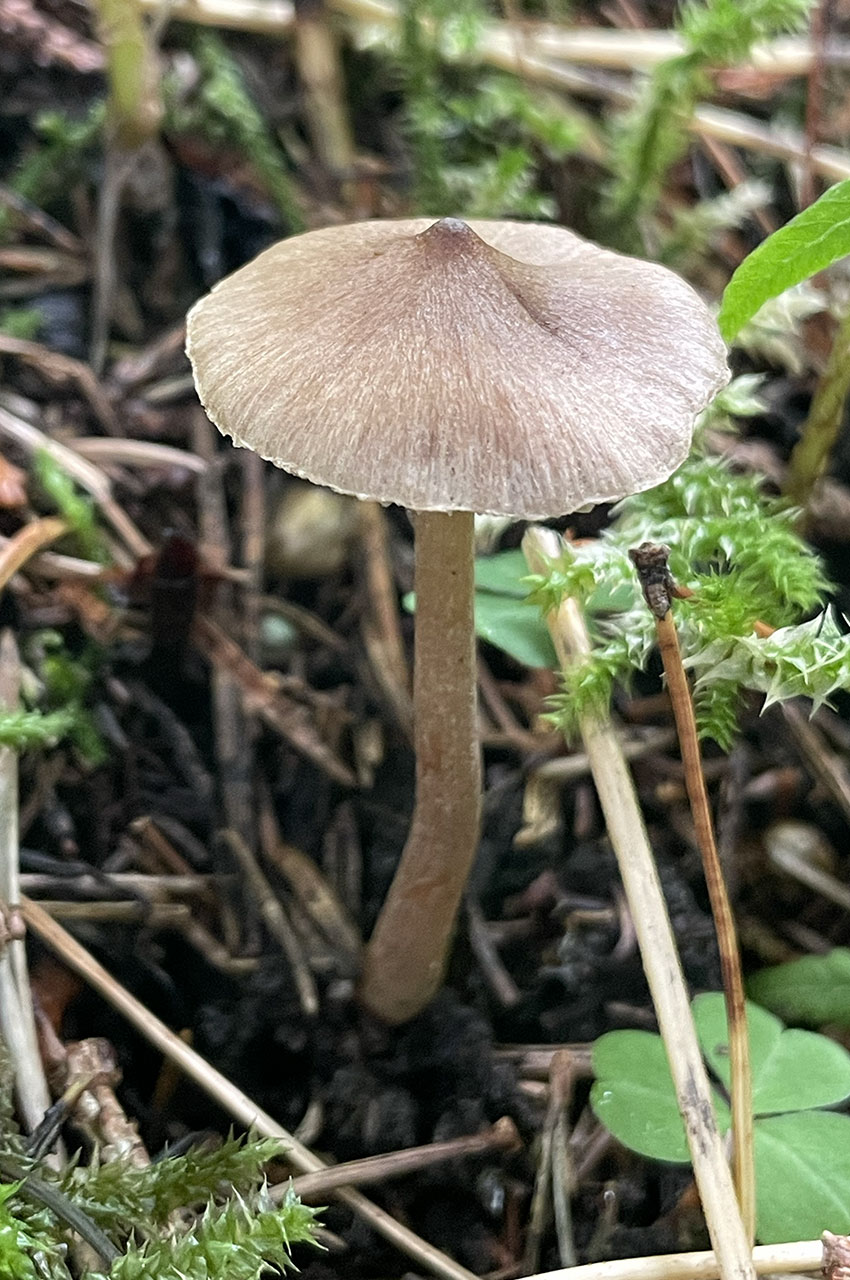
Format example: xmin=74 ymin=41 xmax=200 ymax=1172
xmin=590 ymin=1032 xmax=730 ymax=1164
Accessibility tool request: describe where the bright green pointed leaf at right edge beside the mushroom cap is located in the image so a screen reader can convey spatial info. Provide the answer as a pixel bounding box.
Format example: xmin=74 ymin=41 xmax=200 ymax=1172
xmin=718 ymin=178 xmax=850 ymax=342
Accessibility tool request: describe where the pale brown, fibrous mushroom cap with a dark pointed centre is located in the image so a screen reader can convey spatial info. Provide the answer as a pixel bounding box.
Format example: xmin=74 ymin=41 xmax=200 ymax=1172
xmin=187 ymin=218 xmax=728 ymax=518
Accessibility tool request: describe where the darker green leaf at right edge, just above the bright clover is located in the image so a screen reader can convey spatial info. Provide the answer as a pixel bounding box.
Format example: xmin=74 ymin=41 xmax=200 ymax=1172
xmin=748 ymin=947 xmax=850 ymax=1027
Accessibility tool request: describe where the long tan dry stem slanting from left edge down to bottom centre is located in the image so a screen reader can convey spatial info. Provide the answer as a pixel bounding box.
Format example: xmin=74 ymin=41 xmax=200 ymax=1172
xmin=20 ymin=899 xmax=475 ymax=1280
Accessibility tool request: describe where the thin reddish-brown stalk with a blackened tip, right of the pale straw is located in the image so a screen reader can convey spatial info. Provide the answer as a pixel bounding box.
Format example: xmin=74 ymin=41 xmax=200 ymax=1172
xmin=629 ymin=543 xmax=755 ymax=1243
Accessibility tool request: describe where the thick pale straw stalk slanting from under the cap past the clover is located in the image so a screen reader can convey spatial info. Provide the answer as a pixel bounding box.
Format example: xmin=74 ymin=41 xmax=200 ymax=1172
xmin=522 ymin=529 xmax=754 ymax=1280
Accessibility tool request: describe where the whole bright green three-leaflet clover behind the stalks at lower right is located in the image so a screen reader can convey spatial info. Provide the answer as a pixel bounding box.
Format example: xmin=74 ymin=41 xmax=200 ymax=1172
xmin=590 ymin=993 xmax=850 ymax=1244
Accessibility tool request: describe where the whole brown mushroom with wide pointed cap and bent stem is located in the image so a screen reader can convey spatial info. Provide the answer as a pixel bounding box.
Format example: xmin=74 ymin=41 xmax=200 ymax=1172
xmin=187 ymin=218 xmax=728 ymax=1023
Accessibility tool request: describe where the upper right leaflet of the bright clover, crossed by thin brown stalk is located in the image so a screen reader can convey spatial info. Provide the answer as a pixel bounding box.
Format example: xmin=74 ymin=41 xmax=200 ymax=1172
xmin=693 ymin=992 xmax=850 ymax=1116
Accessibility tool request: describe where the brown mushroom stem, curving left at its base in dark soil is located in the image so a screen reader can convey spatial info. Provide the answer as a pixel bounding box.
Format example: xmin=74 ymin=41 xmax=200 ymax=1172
xmin=360 ymin=511 xmax=481 ymax=1024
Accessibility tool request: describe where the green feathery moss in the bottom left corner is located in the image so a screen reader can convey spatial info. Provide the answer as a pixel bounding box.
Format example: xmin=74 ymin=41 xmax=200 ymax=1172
xmin=0 ymin=1043 xmax=322 ymax=1280
